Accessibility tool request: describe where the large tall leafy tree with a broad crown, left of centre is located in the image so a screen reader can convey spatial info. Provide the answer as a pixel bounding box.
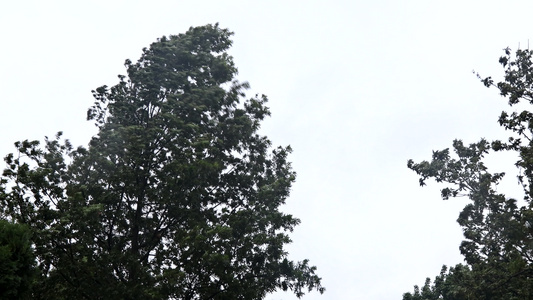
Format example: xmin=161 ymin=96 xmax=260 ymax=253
xmin=0 ymin=24 xmax=324 ymax=299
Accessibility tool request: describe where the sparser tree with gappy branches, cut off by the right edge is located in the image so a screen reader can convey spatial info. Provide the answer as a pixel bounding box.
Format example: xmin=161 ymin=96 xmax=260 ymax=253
xmin=404 ymin=49 xmax=533 ymax=300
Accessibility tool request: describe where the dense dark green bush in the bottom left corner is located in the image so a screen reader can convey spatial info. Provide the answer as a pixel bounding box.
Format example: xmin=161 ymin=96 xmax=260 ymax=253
xmin=0 ymin=219 xmax=36 ymax=299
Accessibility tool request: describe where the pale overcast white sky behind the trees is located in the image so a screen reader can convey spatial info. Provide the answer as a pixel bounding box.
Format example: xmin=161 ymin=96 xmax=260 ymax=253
xmin=0 ymin=0 xmax=533 ymax=300
